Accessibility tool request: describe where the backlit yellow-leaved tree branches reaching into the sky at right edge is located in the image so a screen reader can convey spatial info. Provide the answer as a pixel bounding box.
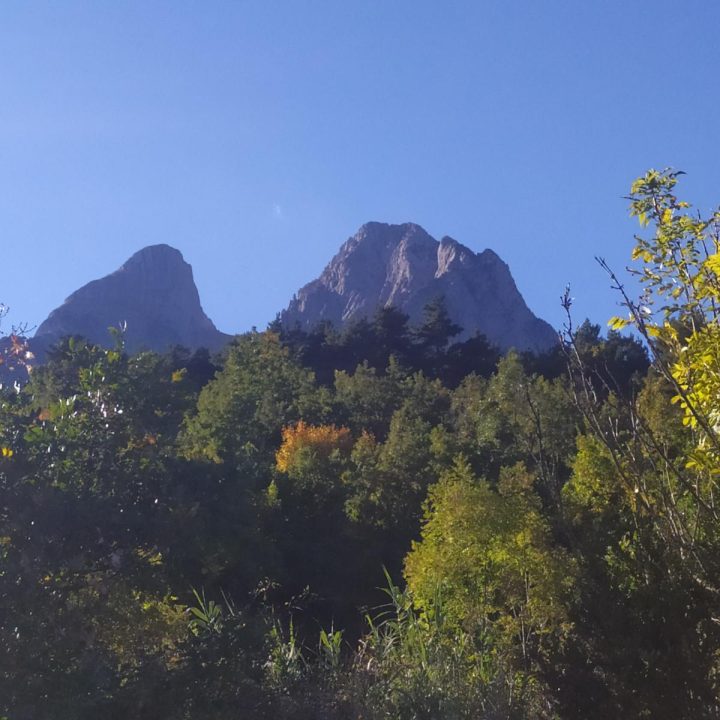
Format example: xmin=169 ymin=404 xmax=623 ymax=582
xmin=601 ymin=170 xmax=720 ymax=600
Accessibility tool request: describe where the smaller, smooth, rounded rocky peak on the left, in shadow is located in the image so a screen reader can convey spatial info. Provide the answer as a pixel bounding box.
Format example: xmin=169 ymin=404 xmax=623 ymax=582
xmin=32 ymin=244 xmax=231 ymax=352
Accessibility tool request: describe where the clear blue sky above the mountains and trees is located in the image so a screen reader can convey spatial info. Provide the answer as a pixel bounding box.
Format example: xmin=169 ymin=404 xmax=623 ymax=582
xmin=0 ymin=0 xmax=720 ymax=332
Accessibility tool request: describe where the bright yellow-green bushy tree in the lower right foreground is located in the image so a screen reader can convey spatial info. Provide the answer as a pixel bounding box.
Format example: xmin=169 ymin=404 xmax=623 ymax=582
xmin=405 ymin=460 xmax=573 ymax=717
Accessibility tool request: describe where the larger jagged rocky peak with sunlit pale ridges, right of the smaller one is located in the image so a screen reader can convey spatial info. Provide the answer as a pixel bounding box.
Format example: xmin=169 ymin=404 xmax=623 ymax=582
xmin=279 ymin=222 xmax=557 ymax=351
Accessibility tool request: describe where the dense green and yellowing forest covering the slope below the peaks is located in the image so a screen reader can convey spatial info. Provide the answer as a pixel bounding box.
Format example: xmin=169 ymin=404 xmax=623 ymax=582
xmin=0 ymin=172 xmax=720 ymax=720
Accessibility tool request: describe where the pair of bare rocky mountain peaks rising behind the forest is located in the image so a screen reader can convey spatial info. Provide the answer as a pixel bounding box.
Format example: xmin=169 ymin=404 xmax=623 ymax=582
xmin=5 ymin=222 xmax=557 ymax=374
